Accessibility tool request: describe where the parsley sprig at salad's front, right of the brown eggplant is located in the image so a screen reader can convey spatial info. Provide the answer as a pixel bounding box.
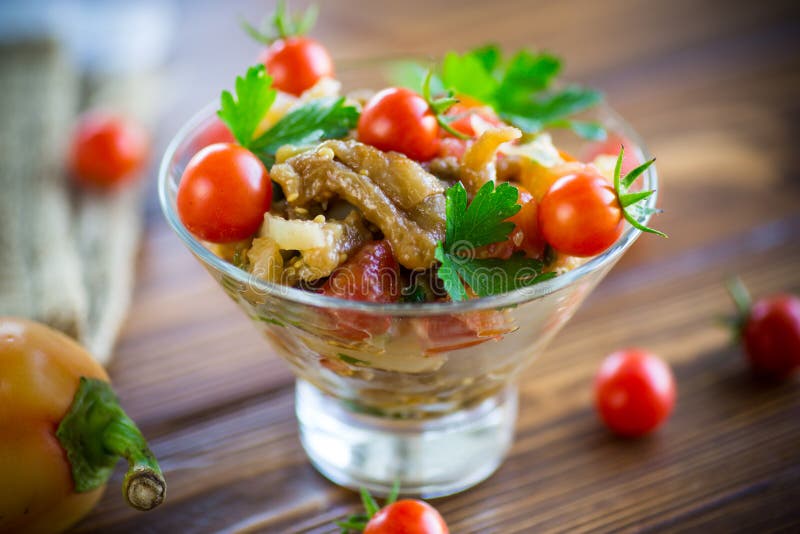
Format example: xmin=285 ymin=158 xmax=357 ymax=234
xmin=435 ymin=181 xmax=555 ymax=301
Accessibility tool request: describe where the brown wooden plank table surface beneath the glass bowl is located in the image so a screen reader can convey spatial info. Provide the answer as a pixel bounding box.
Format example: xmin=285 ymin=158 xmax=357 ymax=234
xmin=72 ymin=0 xmax=800 ymax=533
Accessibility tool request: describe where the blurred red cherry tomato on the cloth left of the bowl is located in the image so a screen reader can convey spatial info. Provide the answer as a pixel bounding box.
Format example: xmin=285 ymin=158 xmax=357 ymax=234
xmin=70 ymin=112 xmax=150 ymax=188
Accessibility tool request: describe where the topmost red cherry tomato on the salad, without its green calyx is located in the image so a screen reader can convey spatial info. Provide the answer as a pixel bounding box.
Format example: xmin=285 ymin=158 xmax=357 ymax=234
xmin=259 ymin=37 xmax=333 ymax=96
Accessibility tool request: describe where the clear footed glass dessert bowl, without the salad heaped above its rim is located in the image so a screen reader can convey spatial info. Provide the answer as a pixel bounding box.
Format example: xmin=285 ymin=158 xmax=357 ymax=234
xmin=159 ymin=62 xmax=657 ymax=497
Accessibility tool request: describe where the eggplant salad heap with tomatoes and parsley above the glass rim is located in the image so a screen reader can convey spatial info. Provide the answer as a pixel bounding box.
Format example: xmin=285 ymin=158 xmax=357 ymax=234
xmin=177 ymin=2 xmax=663 ymax=303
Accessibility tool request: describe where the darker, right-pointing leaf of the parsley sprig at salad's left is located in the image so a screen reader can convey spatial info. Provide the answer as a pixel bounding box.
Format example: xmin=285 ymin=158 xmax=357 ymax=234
xmin=250 ymin=97 xmax=359 ymax=166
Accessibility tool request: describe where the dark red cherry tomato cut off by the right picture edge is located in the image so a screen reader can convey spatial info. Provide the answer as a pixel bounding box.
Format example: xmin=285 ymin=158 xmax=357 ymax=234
xmin=742 ymin=295 xmax=800 ymax=378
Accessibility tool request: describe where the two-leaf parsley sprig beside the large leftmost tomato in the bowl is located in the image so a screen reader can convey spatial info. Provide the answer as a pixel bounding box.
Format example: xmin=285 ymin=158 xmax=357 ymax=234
xmin=217 ymin=65 xmax=359 ymax=166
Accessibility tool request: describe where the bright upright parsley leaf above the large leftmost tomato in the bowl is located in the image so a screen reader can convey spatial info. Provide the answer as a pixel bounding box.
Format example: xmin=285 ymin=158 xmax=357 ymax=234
xmin=217 ymin=65 xmax=278 ymax=147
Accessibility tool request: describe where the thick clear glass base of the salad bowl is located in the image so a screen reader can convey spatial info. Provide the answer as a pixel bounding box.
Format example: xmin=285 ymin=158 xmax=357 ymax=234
xmin=296 ymin=380 xmax=517 ymax=498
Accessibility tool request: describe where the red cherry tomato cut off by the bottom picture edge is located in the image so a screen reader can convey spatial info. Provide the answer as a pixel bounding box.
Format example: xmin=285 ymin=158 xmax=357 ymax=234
xmin=364 ymin=499 xmax=450 ymax=534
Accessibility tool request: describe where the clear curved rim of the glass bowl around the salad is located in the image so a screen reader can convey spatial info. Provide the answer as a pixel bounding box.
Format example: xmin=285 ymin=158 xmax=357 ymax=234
xmin=158 ymin=84 xmax=658 ymax=316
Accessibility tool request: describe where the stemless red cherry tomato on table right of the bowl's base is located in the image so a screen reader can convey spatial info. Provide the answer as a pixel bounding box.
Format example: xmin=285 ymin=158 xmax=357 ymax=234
xmin=595 ymin=349 xmax=675 ymax=437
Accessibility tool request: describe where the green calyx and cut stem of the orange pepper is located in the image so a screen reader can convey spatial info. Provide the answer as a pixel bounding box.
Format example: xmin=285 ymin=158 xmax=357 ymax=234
xmin=56 ymin=377 xmax=167 ymax=510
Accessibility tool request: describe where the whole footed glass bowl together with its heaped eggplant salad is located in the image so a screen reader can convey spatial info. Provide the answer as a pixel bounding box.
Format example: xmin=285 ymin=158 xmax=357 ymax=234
xmin=160 ymin=2 xmax=663 ymax=496
